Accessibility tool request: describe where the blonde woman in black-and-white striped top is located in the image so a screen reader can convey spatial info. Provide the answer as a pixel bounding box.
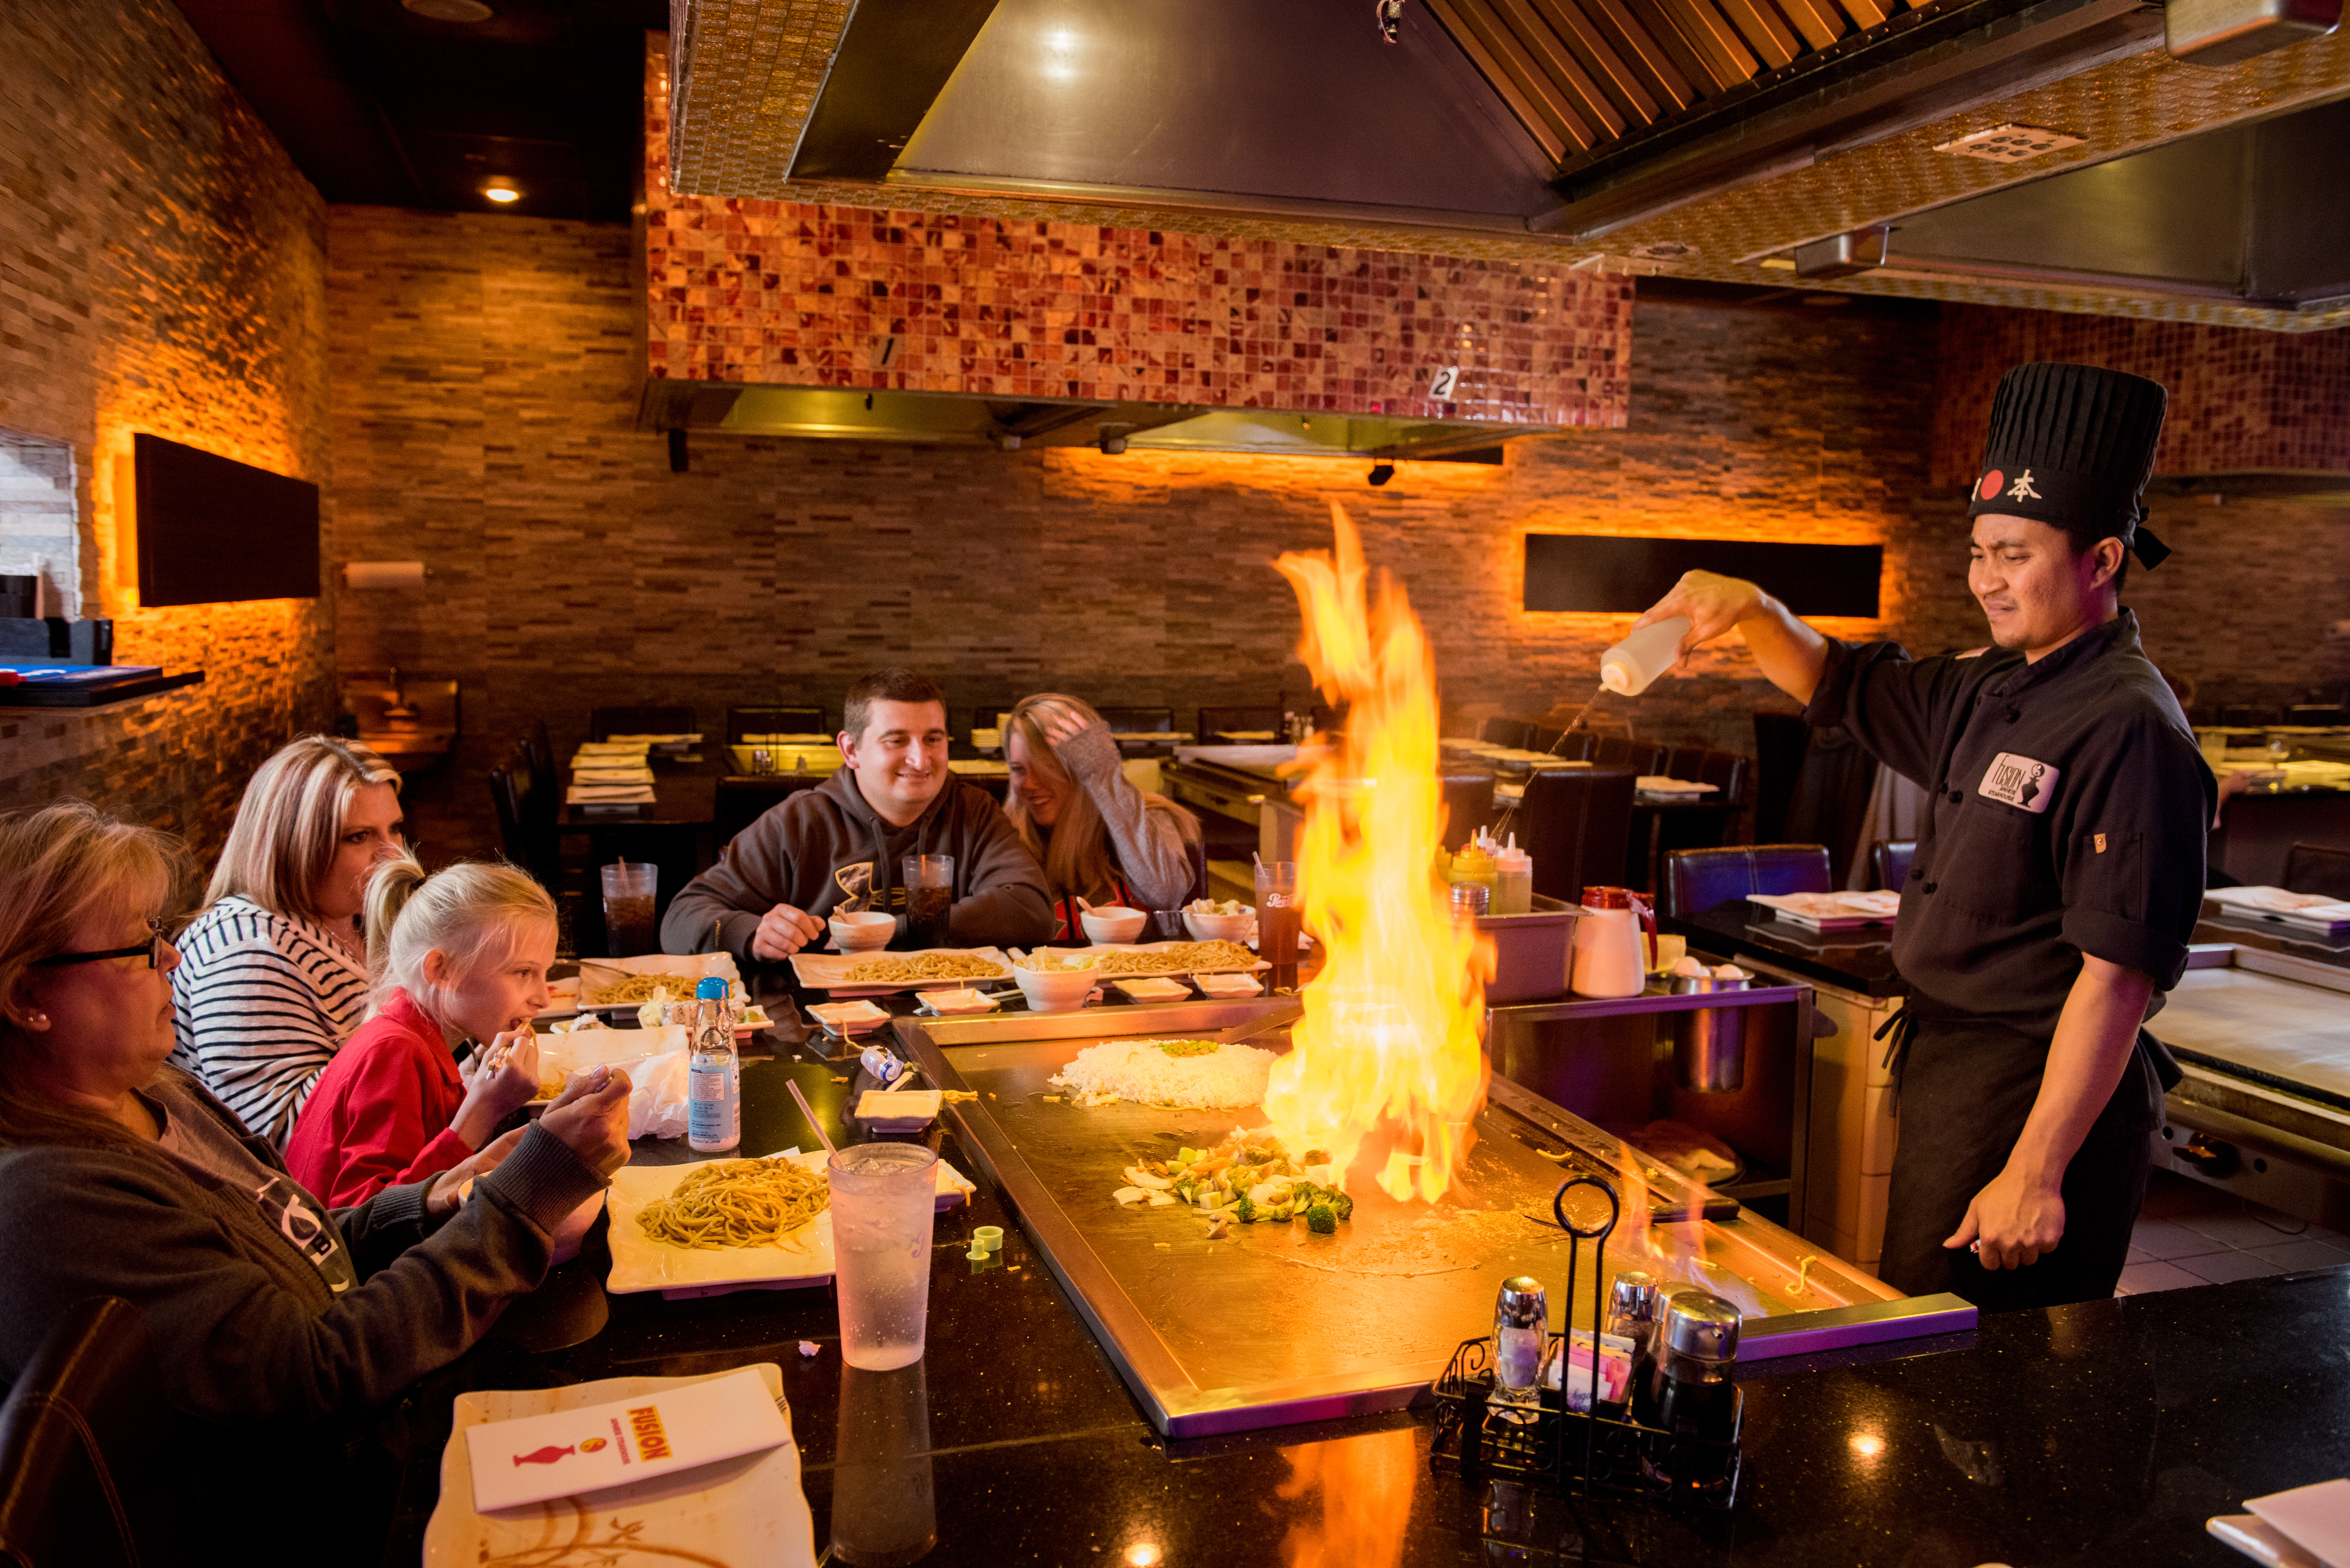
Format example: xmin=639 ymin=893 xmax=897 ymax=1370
xmin=171 ymin=736 xmax=406 ymax=1150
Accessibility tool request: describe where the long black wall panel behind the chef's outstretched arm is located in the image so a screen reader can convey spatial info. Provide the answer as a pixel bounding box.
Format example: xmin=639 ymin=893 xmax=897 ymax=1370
xmin=1525 ymin=534 xmax=1885 ymax=621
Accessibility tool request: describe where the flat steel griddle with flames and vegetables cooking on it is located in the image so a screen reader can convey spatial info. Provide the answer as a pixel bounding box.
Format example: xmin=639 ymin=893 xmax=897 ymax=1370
xmin=895 ymin=999 xmax=1974 ymax=1436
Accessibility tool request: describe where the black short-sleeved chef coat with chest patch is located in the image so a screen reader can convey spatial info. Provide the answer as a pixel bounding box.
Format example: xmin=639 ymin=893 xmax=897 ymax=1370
xmin=1805 ymin=609 xmax=2216 ymax=1041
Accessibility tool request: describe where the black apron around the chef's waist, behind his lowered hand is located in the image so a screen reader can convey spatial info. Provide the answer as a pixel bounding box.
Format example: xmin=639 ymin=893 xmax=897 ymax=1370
xmin=1878 ymin=1006 xmax=2169 ymax=1312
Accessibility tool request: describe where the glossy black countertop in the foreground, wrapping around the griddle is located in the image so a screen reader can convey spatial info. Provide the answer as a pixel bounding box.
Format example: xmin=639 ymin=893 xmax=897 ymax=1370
xmin=383 ymin=1025 xmax=2350 ymax=1568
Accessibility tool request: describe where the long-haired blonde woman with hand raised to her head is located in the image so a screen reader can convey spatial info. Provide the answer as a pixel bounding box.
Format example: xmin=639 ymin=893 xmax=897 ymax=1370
xmin=1004 ymin=691 xmax=1208 ymax=938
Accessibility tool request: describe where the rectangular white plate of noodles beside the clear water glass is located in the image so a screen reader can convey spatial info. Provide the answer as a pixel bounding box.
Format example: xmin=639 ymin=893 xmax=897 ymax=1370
xmin=604 ymin=1150 xmax=832 ymax=1295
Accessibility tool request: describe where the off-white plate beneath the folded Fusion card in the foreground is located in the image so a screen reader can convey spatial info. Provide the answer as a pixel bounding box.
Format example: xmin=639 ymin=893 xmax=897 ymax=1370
xmin=425 ymin=1361 xmax=815 ymax=1568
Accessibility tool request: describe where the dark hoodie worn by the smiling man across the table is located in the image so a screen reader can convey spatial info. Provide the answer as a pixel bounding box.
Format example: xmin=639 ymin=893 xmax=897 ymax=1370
xmin=660 ymin=766 xmax=1053 ymax=964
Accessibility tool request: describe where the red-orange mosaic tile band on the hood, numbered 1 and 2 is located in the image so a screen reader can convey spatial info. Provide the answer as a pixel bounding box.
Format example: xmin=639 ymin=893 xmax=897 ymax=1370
xmin=646 ymin=57 xmax=1631 ymax=428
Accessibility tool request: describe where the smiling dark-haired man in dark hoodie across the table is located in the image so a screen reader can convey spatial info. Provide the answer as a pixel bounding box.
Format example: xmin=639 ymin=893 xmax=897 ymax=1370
xmin=660 ymin=667 xmax=1053 ymax=964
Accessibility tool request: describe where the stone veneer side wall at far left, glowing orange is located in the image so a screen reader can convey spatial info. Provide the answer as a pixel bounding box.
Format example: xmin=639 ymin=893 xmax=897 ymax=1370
xmin=0 ymin=0 xmax=334 ymax=863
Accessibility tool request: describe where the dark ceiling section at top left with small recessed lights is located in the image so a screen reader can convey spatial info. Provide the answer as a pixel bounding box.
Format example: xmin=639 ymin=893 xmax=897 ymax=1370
xmin=178 ymin=0 xmax=670 ymax=223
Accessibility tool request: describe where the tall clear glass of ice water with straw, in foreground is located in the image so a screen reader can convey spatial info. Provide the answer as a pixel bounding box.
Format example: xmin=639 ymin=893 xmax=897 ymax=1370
xmin=825 ymin=1142 xmax=938 ymax=1373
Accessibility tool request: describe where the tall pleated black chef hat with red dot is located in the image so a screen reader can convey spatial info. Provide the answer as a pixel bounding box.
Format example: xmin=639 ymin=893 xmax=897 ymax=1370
xmin=1967 ymin=364 xmax=2169 ymax=567
